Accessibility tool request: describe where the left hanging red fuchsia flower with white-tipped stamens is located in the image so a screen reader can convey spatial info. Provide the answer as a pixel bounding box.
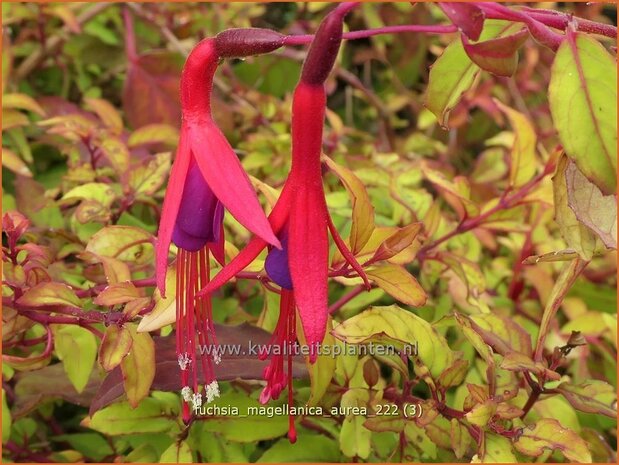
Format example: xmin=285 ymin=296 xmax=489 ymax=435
xmin=156 ymin=29 xmax=283 ymax=421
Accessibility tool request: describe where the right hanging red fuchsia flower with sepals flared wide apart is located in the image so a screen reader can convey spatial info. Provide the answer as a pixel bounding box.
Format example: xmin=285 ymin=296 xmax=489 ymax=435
xmin=198 ymin=4 xmax=369 ymax=441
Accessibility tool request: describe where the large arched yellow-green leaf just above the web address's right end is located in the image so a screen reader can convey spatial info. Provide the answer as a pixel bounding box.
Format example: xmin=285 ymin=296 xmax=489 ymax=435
xmin=333 ymin=305 xmax=453 ymax=379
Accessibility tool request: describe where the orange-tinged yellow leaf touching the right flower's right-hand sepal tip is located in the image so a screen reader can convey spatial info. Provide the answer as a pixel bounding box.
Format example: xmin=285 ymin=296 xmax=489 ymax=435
xmin=366 ymin=263 xmax=427 ymax=307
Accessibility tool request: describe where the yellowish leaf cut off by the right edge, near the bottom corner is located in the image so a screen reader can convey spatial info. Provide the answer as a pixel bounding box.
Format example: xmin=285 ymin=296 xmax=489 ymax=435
xmin=557 ymin=380 xmax=617 ymax=418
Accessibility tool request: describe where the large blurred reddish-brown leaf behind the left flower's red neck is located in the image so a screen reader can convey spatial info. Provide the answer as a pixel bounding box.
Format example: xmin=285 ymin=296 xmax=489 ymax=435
xmin=123 ymin=51 xmax=182 ymax=128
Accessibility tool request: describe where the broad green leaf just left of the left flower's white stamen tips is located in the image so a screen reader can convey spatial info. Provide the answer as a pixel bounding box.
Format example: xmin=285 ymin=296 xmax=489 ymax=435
xmin=81 ymin=397 xmax=179 ymax=436
